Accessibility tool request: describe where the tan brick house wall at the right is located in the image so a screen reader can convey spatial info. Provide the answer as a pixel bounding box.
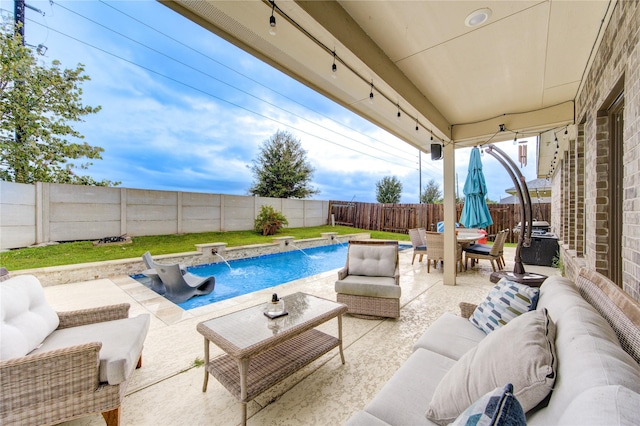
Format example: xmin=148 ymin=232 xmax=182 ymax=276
xmin=552 ymin=1 xmax=640 ymax=301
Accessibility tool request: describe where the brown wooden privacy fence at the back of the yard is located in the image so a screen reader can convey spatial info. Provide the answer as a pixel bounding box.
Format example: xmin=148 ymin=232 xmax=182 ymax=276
xmin=328 ymin=201 xmax=551 ymax=243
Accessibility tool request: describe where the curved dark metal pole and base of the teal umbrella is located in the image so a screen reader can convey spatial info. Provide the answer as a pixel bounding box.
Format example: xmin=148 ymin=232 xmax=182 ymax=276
xmin=485 ymin=144 xmax=547 ymax=287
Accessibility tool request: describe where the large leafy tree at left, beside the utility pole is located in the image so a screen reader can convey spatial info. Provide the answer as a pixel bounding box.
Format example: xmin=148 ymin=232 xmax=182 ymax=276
xmin=0 ymin=30 xmax=119 ymax=186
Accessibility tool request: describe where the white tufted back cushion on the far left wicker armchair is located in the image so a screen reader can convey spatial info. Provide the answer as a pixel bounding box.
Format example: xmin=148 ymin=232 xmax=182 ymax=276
xmin=0 ymin=275 xmax=59 ymax=360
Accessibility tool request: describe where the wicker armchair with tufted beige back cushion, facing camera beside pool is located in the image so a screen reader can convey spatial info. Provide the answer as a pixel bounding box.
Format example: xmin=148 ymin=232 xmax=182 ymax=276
xmin=335 ymin=240 xmax=401 ymax=318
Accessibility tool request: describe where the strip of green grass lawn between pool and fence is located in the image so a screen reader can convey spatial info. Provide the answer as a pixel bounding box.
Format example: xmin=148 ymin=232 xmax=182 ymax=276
xmin=0 ymin=225 xmax=409 ymax=271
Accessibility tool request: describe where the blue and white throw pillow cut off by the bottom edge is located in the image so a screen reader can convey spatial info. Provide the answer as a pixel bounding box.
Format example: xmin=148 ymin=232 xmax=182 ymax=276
xmin=452 ymin=383 xmax=527 ymax=426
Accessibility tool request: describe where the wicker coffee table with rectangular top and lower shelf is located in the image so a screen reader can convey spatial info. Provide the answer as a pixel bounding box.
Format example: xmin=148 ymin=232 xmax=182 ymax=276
xmin=197 ymin=293 xmax=347 ymax=424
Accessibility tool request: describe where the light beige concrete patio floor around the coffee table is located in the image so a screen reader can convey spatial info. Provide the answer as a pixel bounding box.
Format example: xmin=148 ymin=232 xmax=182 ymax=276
xmin=45 ymin=248 xmax=560 ymax=425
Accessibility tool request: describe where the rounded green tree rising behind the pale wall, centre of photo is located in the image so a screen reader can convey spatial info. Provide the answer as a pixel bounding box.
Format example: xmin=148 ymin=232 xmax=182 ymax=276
xmin=249 ymin=130 xmax=320 ymax=198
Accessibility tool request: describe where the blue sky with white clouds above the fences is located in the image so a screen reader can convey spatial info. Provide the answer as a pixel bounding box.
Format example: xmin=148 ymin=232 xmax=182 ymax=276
xmin=0 ymin=0 xmax=536 ymax=203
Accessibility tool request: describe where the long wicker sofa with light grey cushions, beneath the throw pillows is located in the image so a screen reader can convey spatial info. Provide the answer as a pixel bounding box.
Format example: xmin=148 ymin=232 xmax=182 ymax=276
xmin=347 ymin=269 xmax=640 ymax=426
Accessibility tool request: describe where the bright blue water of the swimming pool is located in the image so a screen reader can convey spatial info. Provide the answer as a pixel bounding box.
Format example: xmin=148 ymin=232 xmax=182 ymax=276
xmin=141 ymin=244 xmax=411 ymax=310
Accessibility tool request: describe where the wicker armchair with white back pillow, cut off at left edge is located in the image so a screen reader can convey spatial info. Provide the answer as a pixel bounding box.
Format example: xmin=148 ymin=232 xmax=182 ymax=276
xmin=0 ymin=275 xmax=150 ymax=425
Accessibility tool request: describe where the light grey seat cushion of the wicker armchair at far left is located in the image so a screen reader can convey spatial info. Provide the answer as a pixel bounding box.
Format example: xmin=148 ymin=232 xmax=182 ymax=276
xmin=31 ymin=314 xmax=150 ymax=385
